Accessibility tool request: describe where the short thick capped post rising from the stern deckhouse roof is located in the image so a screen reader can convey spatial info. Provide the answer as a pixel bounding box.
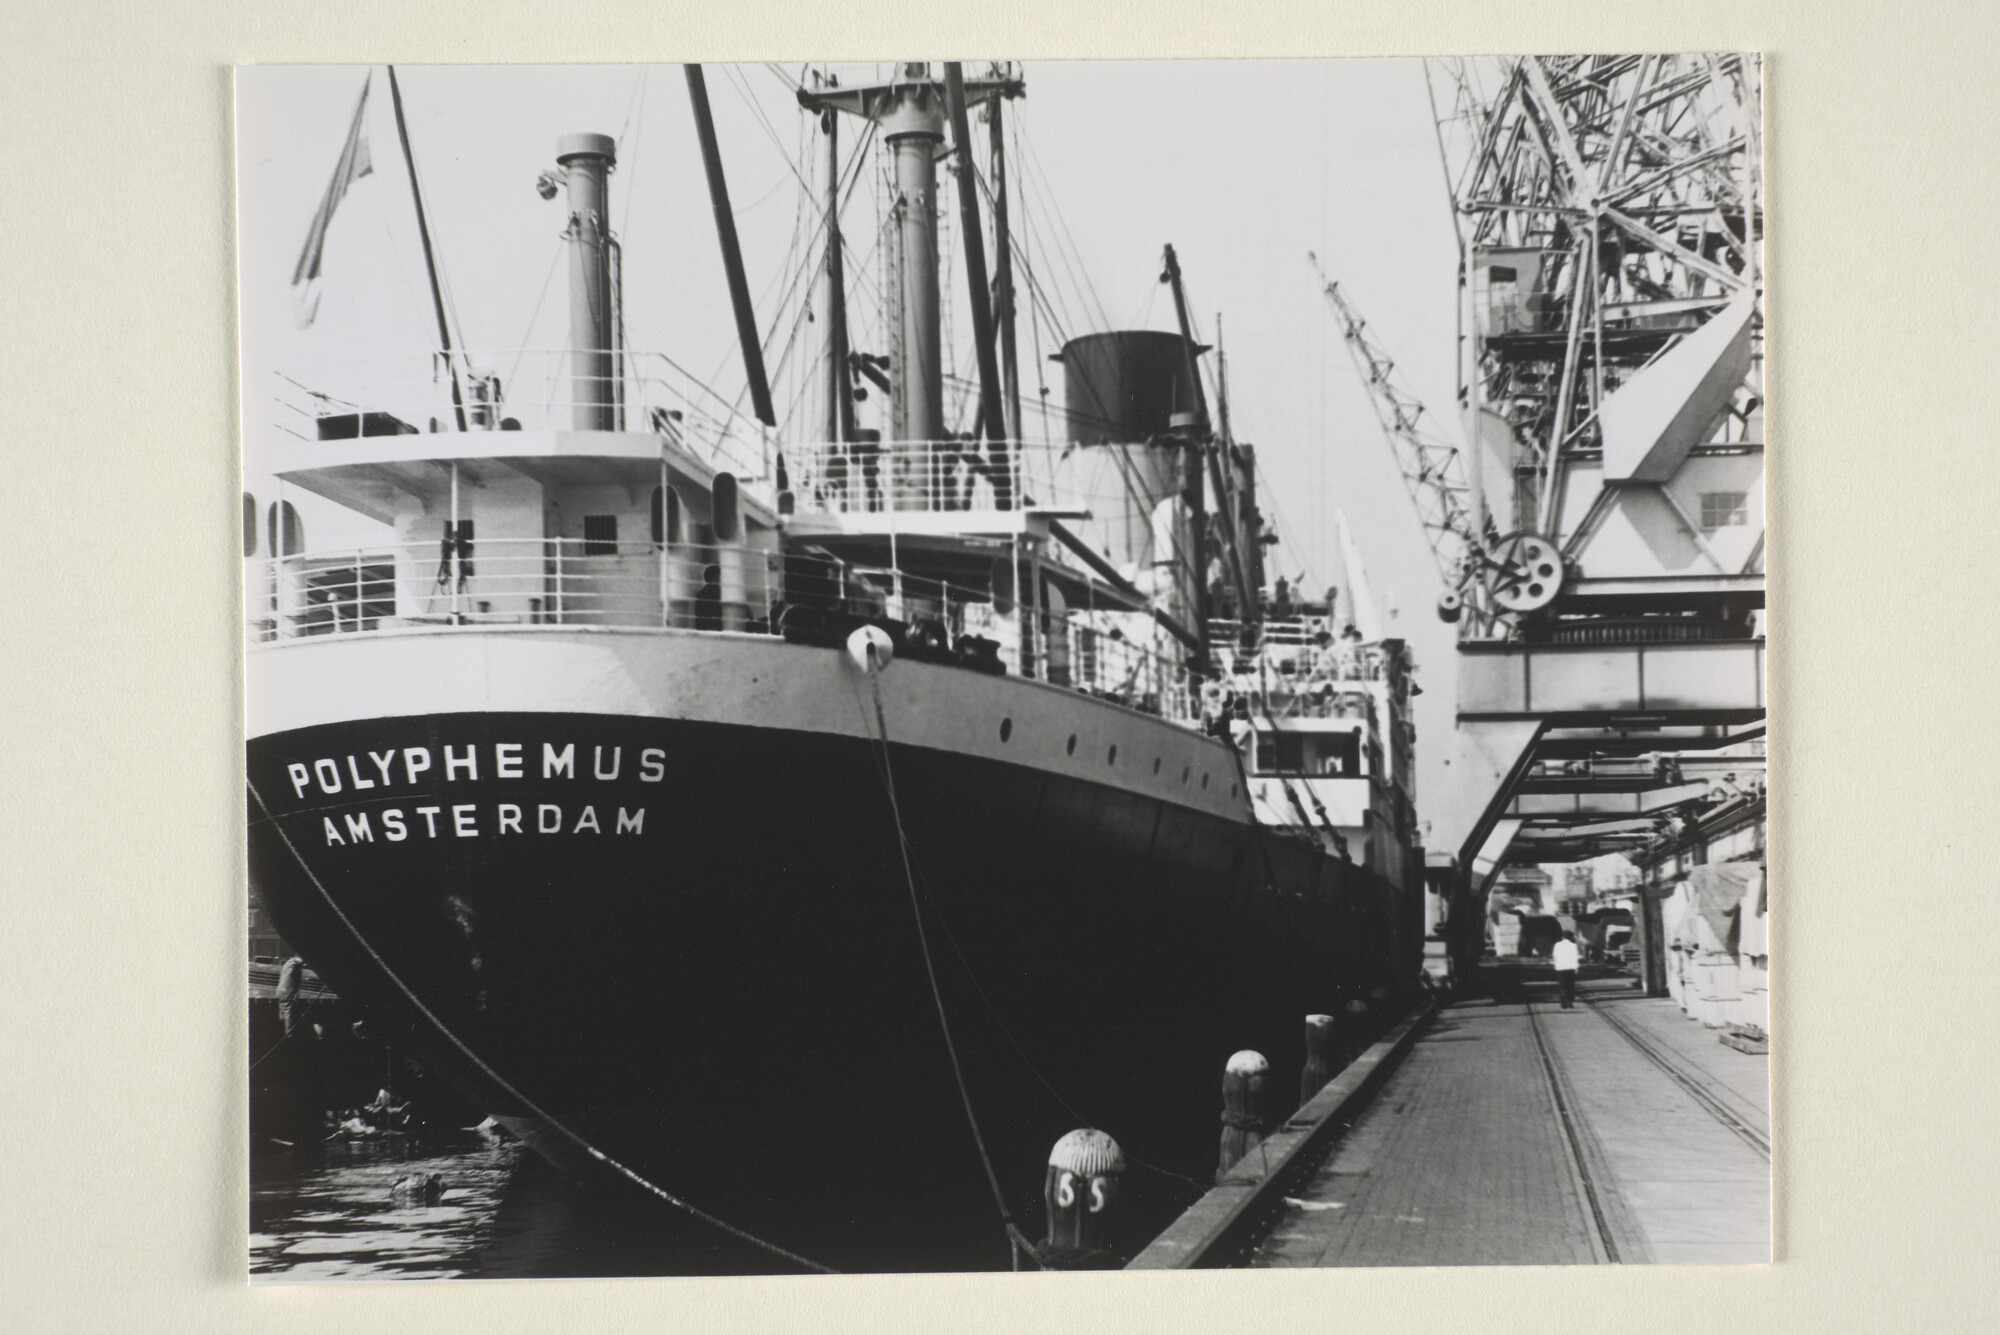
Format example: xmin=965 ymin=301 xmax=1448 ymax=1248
xmin=538 ymin=134 xmax=618 ymax=432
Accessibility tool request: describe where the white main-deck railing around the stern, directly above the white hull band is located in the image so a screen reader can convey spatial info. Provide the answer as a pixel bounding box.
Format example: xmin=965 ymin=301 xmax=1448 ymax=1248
xmin=244 ymin=538 xmax=1192 ymax=717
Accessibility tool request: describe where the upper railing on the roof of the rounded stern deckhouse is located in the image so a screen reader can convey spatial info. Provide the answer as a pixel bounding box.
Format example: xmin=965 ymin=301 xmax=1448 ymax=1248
xmin=272 ymin=348 xmax=770 ymax=480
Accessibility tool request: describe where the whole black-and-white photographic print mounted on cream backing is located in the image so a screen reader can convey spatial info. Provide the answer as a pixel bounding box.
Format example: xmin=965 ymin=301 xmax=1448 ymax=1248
xmin=238 ymin=52 xmax=1768 ymax=1285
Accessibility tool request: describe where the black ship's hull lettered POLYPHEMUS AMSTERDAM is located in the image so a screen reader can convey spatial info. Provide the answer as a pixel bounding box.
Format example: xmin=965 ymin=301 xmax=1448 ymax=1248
xmin=248 ymin=713 xmax=1420 ymax=1271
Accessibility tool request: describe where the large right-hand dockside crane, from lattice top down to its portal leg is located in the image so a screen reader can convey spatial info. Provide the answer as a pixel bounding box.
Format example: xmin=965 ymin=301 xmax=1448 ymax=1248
xmin=1426 ymin=54 xmax=1764 ymax=971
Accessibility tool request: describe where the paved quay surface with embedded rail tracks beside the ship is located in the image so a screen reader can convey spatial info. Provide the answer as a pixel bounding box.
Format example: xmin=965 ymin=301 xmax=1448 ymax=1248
xmin=1252 ymin=961 xmax=1770 ymax=1265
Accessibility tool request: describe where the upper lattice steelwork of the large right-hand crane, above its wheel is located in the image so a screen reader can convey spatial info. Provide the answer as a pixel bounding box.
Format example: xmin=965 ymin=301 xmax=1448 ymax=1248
xmin=1436 ymin=56 xmax=1762 ymax=576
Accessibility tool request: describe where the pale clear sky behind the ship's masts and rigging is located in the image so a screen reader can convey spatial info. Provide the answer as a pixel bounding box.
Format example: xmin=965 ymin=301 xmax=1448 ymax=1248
xmin=236 ymin=60 xmax=1458 ymax=815
